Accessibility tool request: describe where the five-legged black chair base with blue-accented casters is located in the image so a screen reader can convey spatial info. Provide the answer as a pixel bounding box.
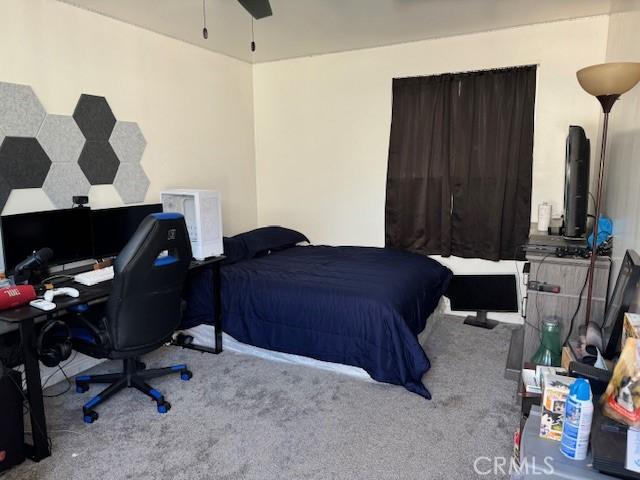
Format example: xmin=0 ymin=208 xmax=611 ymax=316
xmin=76 ymin=358 xmax=193 ymax=423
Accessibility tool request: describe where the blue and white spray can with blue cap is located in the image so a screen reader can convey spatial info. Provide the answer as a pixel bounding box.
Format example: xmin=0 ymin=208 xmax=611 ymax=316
xmin=560 ymin=378 xmax=593 ymax=460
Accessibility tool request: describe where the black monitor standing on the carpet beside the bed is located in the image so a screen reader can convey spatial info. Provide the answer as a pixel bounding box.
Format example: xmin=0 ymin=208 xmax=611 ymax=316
xmin=446 ymin=274 xmax=518 ymax=328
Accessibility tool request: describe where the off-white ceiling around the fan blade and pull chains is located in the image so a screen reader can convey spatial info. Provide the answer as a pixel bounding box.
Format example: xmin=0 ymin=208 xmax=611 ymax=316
xmin=59 ymin=0 xmax=640 ymax=62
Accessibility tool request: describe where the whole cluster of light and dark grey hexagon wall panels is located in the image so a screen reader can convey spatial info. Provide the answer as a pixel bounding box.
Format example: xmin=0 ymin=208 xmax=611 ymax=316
xmin=0 ymin=82 xmax=150 ymax=212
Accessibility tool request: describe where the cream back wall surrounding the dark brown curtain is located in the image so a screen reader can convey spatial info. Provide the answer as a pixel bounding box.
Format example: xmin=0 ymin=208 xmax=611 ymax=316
xmin=254 ymin=16 xmax=608 ymax=248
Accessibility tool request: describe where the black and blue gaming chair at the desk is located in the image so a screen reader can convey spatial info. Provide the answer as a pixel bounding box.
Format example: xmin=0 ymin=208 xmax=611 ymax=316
xmin=65 ymin=213 xmax=192 ymax=423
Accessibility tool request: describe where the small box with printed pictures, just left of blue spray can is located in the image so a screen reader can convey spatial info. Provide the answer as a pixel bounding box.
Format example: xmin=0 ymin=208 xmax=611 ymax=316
xmin=540 ymin=373 xmax=575 ymax=442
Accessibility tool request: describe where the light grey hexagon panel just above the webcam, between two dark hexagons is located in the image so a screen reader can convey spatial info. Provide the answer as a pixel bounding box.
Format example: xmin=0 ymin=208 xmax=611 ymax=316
xmin=42 ymin=162 xmax=91 ymax=208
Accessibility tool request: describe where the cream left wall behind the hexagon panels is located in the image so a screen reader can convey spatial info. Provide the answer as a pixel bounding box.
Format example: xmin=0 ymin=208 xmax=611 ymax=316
xmin=0 ymin=0 xmax=256 ymax=246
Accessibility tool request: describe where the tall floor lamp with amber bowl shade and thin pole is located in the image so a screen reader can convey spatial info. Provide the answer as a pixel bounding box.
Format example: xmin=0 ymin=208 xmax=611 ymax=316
xmin=577 ymin=62 xmax=640 ymax=326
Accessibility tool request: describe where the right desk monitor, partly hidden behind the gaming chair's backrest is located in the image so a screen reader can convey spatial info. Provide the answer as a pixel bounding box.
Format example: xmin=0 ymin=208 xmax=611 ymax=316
xmin=91 ymin=203 xmax=162 ymax=258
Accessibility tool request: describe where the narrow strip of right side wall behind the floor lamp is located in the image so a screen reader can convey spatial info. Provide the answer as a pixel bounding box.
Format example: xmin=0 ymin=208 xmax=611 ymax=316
xmin=594 ymin=12 xmax=640 ymax=278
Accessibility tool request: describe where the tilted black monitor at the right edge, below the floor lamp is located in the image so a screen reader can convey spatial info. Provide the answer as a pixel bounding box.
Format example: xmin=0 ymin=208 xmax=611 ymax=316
xmin=602 ymin=250 xmax=640 ymax=359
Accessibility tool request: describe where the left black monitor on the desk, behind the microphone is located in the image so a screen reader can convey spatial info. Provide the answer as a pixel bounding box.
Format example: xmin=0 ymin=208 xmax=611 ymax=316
xmin=0 ymin=208 xmax=93 ymax=275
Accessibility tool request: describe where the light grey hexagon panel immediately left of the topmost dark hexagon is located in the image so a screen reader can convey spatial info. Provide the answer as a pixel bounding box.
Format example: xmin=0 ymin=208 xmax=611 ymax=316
xmin=37 ymin=115 xmax=84 ymax=163
